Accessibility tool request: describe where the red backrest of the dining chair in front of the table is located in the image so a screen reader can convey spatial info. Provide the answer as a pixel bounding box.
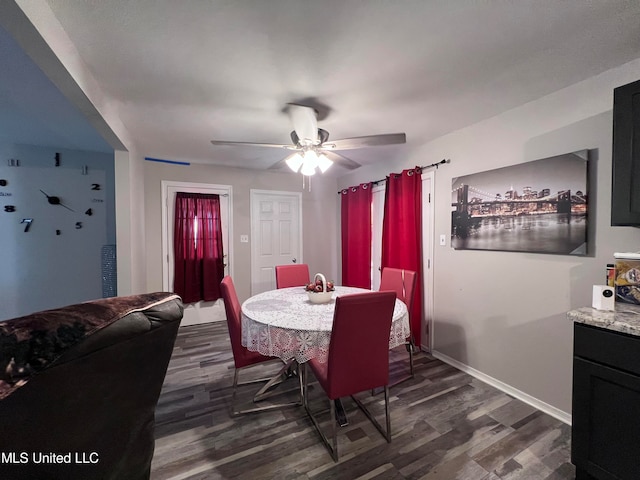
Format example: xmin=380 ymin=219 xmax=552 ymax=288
xmin=327 ymin=291 xmax=396 ymax=399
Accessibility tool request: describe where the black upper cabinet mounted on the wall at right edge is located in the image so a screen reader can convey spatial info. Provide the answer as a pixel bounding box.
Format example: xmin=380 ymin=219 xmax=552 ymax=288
xmin=611 ymin=80 xmax=640 ymax=226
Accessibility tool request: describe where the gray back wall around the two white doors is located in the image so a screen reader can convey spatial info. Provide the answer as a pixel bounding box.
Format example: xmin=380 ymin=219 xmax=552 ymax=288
xmin=144 ymin=162 xmax=339 ymax=302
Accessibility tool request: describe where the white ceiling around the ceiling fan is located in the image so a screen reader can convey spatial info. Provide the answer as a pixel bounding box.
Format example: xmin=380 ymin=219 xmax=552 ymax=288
xmin=0 ymin=0 xmax=640 ymax=173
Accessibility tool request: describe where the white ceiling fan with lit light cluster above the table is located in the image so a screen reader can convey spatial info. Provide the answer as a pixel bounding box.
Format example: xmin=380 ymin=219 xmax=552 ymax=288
xmin=211 ymin=103 xmax=407 ymax=176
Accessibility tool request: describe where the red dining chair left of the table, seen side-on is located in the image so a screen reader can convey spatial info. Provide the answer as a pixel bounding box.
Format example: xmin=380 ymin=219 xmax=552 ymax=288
xmin=220 ymin=275 xmax=302 ymax=416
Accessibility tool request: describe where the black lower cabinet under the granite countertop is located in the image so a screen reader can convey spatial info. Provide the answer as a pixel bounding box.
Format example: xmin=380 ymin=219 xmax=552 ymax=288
xmin=571 ymin=323 xmax=640 ymax=480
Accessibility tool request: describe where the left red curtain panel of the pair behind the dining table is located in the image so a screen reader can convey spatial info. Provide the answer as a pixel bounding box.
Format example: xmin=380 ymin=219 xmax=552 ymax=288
xmin=340 ymin=183 xmax=373 ymax=289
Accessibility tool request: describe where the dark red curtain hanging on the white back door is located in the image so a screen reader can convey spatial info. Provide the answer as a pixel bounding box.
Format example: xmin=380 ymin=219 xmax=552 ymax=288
xmin=173 ymin=192 xmax=224 ymax=303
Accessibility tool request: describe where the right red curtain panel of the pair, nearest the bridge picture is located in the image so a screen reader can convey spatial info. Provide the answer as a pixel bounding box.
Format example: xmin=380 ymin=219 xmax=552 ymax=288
xmin=382 ymin=171 xmax=422 ymax=347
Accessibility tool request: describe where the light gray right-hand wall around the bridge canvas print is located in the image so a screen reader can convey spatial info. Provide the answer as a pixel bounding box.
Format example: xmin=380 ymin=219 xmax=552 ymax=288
xmin=338 ymin=60 xmax=640 ymax=417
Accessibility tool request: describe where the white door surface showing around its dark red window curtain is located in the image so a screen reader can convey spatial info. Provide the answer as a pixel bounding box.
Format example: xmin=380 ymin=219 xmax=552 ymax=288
xmin=162 ymin=181 xmax=233 ymax=326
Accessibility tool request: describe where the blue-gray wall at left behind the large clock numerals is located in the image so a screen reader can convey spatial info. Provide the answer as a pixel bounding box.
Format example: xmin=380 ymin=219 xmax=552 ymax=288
xmin=0 ymin=144 xmax=116 ymax=320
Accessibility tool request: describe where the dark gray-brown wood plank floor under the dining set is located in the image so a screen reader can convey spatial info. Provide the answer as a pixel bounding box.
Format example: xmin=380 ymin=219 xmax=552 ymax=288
xmin=151 ymin=323 xmax=575 ymax=480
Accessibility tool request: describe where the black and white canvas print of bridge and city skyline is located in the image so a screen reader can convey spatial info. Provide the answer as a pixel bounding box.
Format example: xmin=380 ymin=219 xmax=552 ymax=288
xmin=451 ymin=150 xmax=588 ymax=255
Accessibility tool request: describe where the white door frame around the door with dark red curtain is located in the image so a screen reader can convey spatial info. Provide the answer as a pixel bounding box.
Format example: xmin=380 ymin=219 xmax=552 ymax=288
xmin=161 ymin=180 xmax=235 ymax=292
